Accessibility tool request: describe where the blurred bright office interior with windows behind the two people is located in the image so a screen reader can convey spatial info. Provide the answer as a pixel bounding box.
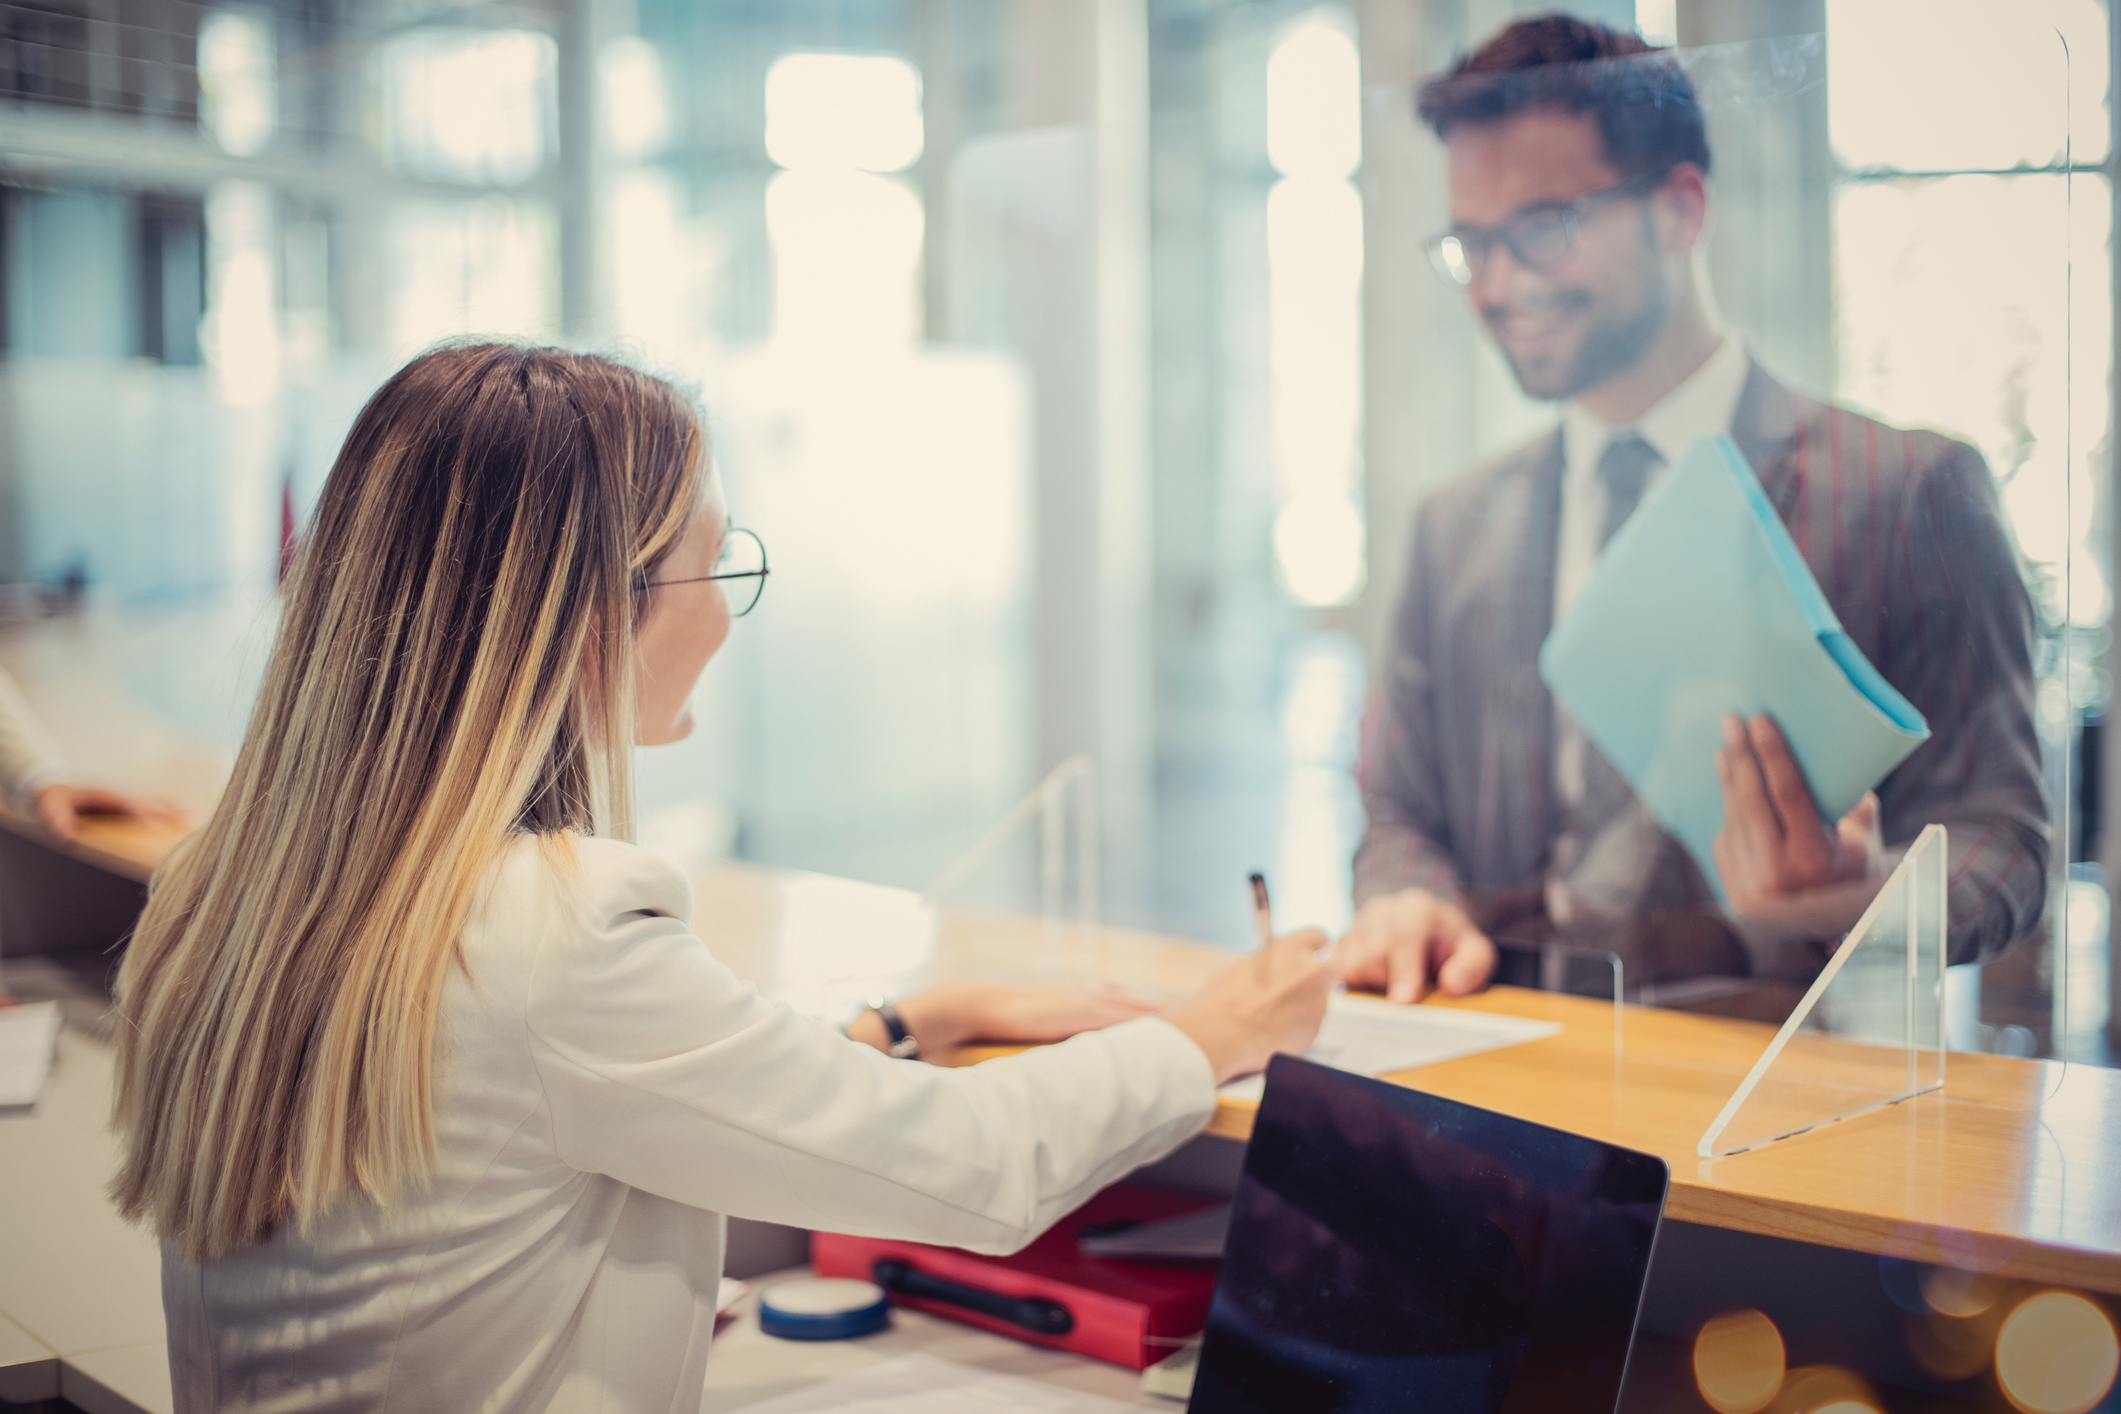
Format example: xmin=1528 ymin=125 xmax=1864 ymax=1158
xmin=0 ymin=0 xmax=2121 ymax=1064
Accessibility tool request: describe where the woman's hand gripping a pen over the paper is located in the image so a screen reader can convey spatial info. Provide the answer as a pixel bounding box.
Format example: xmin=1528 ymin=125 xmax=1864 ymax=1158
xmin=1164 ymin=929 xmax=1334 ymax=1085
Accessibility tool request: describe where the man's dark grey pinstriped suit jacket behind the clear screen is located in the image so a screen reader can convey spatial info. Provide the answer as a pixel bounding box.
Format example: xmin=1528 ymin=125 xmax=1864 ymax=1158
xmin=1355 ymin=365 xmax=2049 ymax=962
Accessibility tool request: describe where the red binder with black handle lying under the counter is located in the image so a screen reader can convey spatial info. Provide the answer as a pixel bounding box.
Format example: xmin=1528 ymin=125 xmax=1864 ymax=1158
xmin=810 ymin=1183 xmax=1217 ymax=1369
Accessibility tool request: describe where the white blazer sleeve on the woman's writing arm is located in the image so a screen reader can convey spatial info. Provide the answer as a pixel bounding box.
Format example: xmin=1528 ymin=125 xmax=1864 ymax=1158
xmin=526 ymin=839 xmax=1215 ymax=1253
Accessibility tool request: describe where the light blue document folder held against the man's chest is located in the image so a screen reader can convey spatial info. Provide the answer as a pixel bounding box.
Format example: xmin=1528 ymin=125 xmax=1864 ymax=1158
xmin=1540 ymin=437 xmax=1930 ymax=892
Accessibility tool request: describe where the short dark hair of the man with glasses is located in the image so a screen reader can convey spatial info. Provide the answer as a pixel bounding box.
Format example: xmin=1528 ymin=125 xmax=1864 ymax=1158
xmin=1415 ymin=15 xmax=1710 ymax=178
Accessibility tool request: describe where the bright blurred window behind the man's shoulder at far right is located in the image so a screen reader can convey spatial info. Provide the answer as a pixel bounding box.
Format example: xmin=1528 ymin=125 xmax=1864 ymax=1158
xmin=1826 ymin=0 xmax=2113 ymax=648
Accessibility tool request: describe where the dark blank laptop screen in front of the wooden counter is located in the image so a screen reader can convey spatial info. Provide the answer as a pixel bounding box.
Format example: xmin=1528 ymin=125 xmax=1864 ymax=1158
xmin=1188 ymin=1056 xmax=1669 ymax=1414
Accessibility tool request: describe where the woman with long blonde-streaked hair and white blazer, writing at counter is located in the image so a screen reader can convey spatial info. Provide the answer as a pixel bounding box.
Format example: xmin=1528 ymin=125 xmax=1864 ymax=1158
xmin=112 ymin=346 xmax=1328 ymax=1412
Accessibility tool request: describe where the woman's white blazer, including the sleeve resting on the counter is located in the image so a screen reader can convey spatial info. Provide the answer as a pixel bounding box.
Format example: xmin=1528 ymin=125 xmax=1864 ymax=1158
xmin=163 ymin=839 xmax=1215 ymax=1414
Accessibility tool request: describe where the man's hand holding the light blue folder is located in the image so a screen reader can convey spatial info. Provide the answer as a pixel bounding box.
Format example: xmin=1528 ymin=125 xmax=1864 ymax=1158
xmin=1716 ymin=714 xmax=1886 ymax=933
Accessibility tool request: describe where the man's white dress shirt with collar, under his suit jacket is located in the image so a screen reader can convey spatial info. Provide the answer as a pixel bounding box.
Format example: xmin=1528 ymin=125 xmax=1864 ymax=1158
xmin=1555 ymin=335 xmax=1752 ymax=803
